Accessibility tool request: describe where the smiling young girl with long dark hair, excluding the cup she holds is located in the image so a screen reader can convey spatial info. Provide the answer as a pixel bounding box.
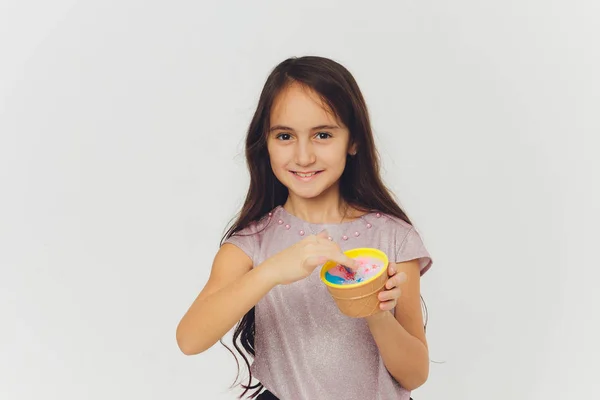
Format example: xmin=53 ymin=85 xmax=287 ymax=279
xmin=177 ymin=57 xmax=432 ymax=400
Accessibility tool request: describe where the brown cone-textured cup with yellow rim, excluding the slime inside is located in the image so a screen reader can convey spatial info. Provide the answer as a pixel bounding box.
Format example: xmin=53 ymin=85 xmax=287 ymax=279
xmin=320 ymin=247 xmax=389 ymax=318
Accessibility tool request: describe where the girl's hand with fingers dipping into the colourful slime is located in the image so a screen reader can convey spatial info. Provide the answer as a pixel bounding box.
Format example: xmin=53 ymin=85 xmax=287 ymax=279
xmin=263 ymin=231 xmax=358 ymax=285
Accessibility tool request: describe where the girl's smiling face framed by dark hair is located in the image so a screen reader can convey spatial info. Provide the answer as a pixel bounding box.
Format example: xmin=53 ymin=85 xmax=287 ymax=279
xmin=267 ymin=84 xmax=355 ymax=199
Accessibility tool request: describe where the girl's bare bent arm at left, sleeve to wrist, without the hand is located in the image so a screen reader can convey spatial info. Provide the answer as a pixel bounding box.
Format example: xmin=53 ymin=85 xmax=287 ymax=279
xmin=176 ymin=243 xmax=277 ymax=355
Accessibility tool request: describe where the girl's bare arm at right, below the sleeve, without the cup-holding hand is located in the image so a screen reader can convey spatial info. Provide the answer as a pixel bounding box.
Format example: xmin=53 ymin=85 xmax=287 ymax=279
xmin=366 ymin=260 xmax=429 ymax=390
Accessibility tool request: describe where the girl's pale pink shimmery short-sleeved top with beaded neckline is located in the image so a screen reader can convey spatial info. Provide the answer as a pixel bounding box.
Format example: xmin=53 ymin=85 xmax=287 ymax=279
xmin=225 ymin=206 xmax=432 ymax=400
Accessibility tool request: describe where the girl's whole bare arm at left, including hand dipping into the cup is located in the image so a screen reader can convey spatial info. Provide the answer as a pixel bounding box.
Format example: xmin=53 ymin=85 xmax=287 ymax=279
xmin=177 ymin=231 xmax=356 ymax=355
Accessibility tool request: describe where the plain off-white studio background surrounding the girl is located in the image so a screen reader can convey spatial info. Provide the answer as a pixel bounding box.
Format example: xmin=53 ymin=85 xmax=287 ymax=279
xmin=0 ymin=0 xmax=600 ymax=400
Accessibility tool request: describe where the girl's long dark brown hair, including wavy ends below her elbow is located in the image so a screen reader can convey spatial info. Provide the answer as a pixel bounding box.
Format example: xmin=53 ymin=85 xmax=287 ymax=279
xmin=221 ymin=56 xmax=426 ymax=398
